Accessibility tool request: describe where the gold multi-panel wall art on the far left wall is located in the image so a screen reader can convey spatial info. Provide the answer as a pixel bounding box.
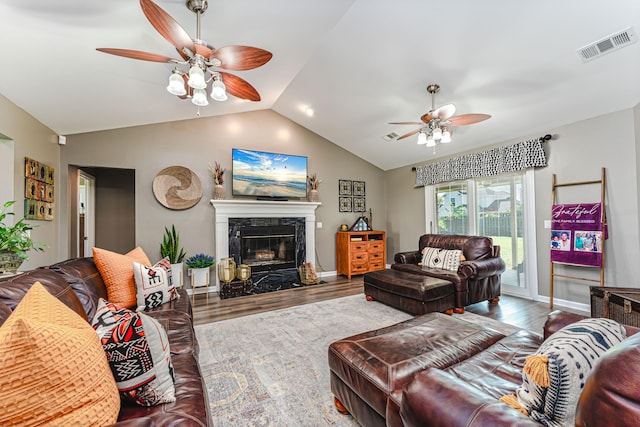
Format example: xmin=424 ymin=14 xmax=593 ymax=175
xmin=24 ymin=157 xmax=55 ymax=221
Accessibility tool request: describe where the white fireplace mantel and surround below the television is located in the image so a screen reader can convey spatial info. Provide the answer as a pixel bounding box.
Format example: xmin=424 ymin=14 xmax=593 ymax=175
xmin=210 ymin=200 xmax=321 ymax=292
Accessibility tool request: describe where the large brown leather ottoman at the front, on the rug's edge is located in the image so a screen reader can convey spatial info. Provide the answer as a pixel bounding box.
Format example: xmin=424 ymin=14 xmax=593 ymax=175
xmin=329 ymin=313 xmax=504 ymax=426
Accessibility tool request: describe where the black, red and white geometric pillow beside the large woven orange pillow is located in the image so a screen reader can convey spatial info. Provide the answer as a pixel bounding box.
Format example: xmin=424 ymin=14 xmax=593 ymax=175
xmin=92 ymin=298 xmax=176 ymax=406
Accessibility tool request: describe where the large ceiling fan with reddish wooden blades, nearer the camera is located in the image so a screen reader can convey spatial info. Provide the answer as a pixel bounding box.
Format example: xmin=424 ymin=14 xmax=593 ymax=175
xmin=97 ymin=0 xmax=273 ymax=107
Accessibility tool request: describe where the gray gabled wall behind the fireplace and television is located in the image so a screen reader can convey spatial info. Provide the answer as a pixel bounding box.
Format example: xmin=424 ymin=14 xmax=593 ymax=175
xmin=60 ymin=110 xmax=388 ymax=271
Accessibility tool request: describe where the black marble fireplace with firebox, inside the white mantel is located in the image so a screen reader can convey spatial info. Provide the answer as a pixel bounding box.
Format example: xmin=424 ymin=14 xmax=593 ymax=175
xmin=229 ymin=218 xmax=306 ymax=273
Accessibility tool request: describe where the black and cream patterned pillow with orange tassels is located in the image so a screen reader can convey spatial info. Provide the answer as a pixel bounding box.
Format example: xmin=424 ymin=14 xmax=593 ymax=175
xmin=500 ymin=318 xmax=626 ymax=426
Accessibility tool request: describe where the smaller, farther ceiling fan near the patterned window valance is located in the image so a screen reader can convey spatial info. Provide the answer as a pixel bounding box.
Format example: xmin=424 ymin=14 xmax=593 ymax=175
xmin=389 ymin=84 xmax=491 ymax=147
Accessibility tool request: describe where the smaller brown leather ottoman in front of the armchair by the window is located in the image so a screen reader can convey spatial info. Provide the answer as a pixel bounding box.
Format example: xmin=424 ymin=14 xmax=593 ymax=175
xmin=364 ymin=270 xmax=456 ymax=315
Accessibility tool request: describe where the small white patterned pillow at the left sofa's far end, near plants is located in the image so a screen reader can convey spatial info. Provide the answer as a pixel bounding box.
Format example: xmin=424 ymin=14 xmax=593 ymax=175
xmin=133 ymin=258 xmax=178 ymax=311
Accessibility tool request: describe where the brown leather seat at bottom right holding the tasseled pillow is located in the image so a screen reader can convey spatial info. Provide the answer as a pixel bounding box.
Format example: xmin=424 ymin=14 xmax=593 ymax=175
xmin=400 ymin=311 xmax=640 ymax=427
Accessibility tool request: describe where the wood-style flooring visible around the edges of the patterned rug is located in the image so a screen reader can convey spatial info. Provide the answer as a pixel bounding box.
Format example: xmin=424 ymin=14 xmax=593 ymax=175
xmin=193 ymin=276 xmax=589 ymax=333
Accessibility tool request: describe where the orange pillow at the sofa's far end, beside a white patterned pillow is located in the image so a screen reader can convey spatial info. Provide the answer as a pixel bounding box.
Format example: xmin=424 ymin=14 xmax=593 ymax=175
xmin=93 ymin=247 xmax=151 ymax=308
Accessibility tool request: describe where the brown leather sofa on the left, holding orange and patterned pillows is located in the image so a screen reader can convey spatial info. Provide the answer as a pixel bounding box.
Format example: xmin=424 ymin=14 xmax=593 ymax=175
xmin=0 ymin=258 xmax=212 ymax=427
